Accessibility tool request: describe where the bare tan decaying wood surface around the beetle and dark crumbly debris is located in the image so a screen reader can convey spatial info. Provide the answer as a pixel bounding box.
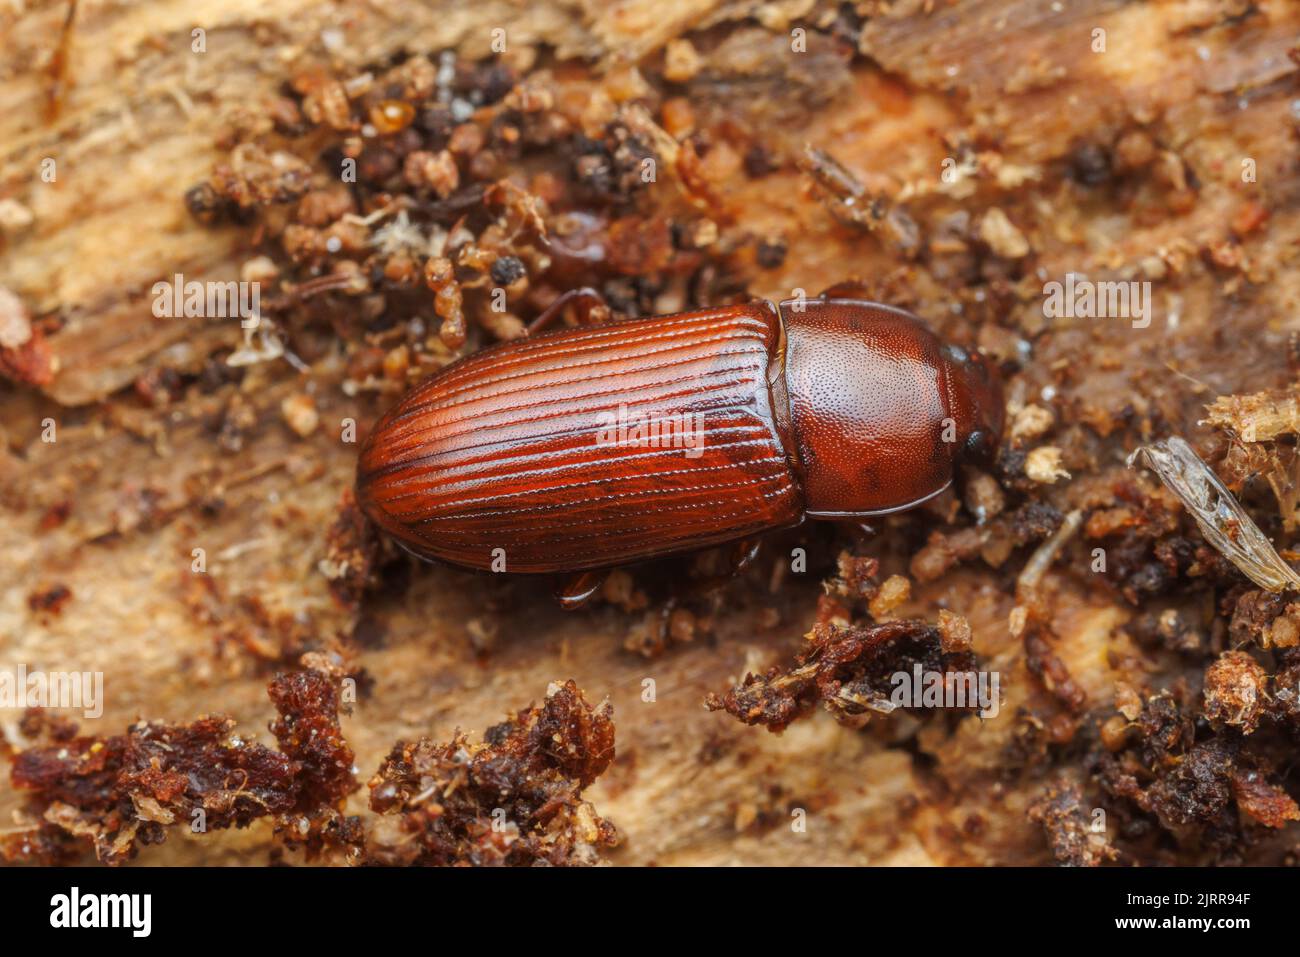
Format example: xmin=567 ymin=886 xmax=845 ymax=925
xmin=0 ymin=0 xmax=1300 ymax=863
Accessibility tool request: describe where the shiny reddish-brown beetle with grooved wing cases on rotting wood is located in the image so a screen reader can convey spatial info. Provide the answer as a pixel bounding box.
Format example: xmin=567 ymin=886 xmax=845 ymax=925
xmin=356 ymin=287 xmax=1004 ymax=603
